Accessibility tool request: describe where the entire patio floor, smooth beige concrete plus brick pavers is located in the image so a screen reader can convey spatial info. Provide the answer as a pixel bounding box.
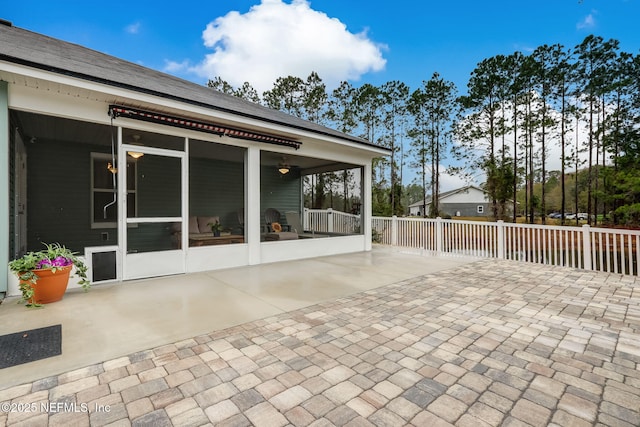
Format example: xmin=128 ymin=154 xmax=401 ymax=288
xmin=0 ymin=249 xmax=640 ymax=427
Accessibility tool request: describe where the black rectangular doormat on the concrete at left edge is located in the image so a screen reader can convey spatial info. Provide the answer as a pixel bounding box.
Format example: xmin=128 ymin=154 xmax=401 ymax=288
xmin=0 ymin=325 xmax=62 ymax=369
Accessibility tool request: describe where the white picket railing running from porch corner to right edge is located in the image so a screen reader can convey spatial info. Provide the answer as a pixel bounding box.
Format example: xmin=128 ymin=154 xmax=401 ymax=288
xmin=372 ymin=217 xmax=640 ymax=276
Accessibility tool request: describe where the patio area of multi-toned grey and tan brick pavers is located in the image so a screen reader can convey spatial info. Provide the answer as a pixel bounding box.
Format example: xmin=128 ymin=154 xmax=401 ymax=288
xmin=0 ymin=260 xmax=640 ymax=426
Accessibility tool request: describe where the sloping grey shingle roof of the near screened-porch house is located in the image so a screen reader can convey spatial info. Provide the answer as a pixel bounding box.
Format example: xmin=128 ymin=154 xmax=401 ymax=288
xmin=0 ymin=20 xmax=390 ymax=152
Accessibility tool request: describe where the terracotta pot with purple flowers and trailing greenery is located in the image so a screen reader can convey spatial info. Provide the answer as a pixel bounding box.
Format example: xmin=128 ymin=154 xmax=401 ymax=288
xmin=9 ymin=243 xmax=91 ymax=307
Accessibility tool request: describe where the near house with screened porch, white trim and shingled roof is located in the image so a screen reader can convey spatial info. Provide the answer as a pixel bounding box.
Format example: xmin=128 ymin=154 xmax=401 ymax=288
xmin=0 ymin=21 xmax=390 ymax=294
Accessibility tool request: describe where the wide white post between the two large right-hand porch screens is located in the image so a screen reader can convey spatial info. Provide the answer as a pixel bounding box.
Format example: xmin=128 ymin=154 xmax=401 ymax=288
xmin=244 ymin=147 xmax=261 ymax=265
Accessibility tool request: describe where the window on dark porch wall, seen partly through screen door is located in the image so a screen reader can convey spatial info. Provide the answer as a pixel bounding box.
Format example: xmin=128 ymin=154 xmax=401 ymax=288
xmin=91 ymin=153 xmax=137 ymax=228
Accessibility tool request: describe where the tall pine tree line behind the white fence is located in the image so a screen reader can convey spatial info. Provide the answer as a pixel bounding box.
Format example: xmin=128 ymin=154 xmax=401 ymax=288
xmin=208 ymin=35 xmax=640 ymax=225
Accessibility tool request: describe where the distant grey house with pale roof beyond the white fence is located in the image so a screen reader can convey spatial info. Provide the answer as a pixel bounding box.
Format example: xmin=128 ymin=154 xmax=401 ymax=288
xmin=409 ymin=185 xmax=492 ymax=217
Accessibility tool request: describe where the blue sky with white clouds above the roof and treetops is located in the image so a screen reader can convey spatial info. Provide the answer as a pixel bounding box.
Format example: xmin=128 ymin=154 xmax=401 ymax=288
xmin=5 ymin=0 xmax=640 ymax=189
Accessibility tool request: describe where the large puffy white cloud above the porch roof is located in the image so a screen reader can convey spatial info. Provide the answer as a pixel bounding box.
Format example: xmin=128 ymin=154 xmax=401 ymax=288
xmin=191 ymin=0 xmax=386 ymax=93
